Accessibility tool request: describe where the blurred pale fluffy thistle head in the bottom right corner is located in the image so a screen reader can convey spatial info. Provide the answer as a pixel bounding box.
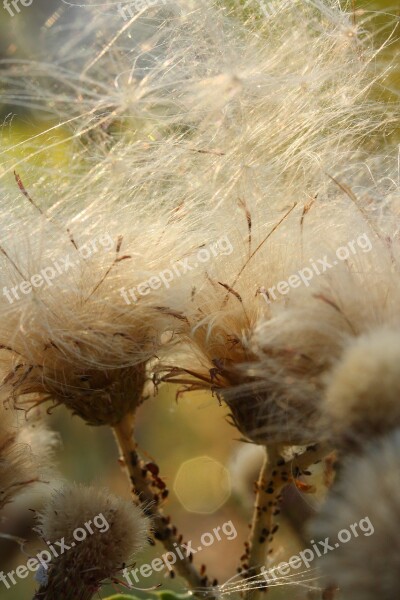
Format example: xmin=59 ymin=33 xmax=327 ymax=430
xmin=312 ymin=430 xmax=400 ymax=600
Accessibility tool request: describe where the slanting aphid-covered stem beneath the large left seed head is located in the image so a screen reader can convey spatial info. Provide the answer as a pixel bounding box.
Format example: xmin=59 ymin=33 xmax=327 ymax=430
xmin=113 ymin=414 xmax=209 ymax=596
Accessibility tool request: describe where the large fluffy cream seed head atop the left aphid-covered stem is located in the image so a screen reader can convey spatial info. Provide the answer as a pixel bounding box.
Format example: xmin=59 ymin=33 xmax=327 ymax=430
xmin=0 ymin=180 xmax=196 ymax=425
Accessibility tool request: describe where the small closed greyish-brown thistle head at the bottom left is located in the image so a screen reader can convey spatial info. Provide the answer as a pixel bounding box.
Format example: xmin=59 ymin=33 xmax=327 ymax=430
xmin=36 ymin=485 xmax=149 ymax=600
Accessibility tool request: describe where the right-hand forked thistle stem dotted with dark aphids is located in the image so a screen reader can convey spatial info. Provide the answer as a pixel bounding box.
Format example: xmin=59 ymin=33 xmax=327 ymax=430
xmin=244 ymin=445 xmax=332 ymax=600
